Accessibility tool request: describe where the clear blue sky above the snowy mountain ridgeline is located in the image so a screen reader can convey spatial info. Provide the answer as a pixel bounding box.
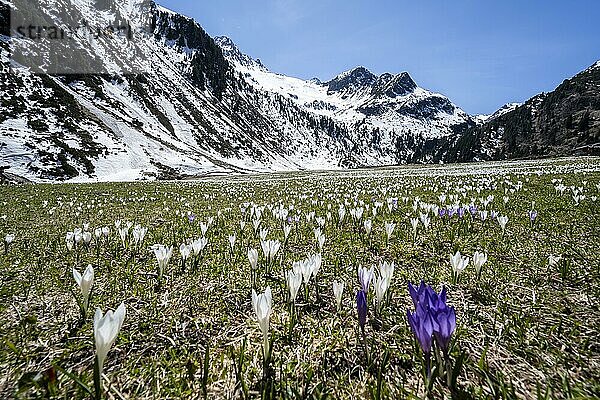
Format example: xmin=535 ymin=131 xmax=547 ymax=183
xmin=158 ymin=0 xmax=600 ymax=114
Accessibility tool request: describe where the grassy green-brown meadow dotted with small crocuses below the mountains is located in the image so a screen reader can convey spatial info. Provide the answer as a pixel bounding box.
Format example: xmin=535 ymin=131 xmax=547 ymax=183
xmin=0 ymin=158 xmax=600 ymax=399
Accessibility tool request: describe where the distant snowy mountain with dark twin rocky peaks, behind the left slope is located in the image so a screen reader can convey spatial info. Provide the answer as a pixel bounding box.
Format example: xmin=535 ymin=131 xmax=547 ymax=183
xmin=215 ymin=37 xmax=471 ymax=142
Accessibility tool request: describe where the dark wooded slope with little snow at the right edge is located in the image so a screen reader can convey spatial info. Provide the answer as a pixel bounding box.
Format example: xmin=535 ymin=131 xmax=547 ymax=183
xmin=450 ymin=63 xmax=600 ymax=161
